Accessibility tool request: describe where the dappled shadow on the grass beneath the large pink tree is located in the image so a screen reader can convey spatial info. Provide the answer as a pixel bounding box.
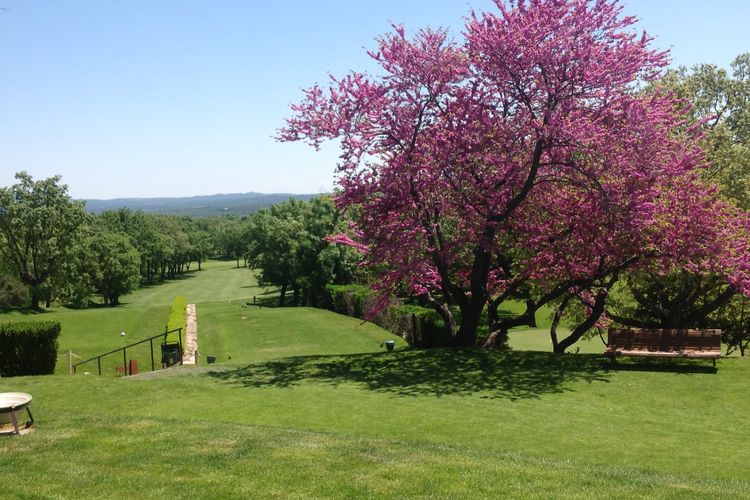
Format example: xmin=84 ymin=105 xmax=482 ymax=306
xmin=209 ymin=349 xmax=609 ymax=400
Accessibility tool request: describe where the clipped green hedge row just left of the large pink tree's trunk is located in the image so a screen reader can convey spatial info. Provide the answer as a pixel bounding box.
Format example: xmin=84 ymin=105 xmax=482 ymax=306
xmin=326 ymin=285 xmax=451 ymax=347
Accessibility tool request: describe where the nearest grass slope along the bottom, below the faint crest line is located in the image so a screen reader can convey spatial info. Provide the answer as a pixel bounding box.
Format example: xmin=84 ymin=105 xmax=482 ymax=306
xmin=0 ymin=417 xmax=746 ymax=498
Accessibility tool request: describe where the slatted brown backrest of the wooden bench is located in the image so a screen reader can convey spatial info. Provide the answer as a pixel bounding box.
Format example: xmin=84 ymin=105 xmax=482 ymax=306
xmin=608 ymin=328 xmax=721 ymax=352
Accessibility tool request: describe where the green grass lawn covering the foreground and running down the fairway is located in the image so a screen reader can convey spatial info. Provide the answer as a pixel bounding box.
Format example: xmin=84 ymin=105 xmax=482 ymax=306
xmin=0 ymin=263 xmax=750 ymax=498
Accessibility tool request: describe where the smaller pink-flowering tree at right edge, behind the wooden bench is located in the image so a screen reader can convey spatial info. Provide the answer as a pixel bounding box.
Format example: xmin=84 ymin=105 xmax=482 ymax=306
xmin=544 ymin=176 xmax=750 ymax=352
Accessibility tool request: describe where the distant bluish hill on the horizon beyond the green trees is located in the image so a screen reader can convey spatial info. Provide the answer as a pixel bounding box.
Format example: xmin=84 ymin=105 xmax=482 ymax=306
xmin=82 ymin=193 xmax=318 ymax=217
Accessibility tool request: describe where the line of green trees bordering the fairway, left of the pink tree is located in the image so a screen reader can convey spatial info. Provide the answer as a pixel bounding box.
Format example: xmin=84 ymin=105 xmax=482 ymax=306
xmin=0 ymin=172 xmax=357 ymax=309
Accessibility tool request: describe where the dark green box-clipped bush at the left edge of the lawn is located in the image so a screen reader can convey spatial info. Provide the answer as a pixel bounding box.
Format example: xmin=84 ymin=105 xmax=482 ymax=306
xmin=0 ymin=321 xmax=60 ymax=377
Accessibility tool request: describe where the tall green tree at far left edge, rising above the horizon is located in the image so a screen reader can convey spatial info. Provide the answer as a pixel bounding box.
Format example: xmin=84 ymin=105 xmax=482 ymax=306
xmin=0 ymin=172 xmax=87 ymax=309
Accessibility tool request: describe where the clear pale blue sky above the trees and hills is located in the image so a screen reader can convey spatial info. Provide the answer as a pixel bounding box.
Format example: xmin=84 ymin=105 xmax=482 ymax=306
xmin=0 ymin=0 xmax=750 ymax=198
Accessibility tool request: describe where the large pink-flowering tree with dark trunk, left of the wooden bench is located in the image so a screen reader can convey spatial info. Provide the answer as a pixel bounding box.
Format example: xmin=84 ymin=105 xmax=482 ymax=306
xmin=279 ymin=0 xmax=750 ymax=346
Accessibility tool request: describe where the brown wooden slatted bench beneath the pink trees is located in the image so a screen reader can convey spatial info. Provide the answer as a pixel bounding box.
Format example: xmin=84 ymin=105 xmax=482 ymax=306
xmin=604 ymin=328 xmax=721 ymax=368
